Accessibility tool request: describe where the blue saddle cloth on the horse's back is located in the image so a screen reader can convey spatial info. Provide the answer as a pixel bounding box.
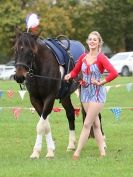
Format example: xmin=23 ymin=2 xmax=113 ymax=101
xmin=44 ymin=39 xmax=85 ymax=68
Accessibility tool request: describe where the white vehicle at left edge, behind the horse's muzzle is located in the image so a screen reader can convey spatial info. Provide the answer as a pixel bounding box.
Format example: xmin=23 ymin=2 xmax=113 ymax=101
xmin=0 ymin=65 xmax=16 ymax=80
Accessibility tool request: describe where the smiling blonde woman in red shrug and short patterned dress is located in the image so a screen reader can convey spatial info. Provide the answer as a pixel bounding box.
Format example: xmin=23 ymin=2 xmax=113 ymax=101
xmin=65 ymin=31 xmax=118 ymax=160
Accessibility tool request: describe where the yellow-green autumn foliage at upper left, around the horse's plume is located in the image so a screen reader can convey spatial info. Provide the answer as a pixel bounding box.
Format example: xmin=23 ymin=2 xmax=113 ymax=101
xmin=0 ymin=0 xmax=74 ymax=60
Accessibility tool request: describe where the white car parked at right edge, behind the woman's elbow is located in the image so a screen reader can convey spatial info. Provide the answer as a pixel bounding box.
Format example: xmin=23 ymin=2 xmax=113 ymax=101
xmin=109 ymin=52 xmax=133 ymax=76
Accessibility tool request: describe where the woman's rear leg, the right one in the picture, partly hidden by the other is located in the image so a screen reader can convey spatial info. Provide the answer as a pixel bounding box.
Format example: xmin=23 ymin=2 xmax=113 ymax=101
xmin=93 ymin=116 xmax=105 ymax=156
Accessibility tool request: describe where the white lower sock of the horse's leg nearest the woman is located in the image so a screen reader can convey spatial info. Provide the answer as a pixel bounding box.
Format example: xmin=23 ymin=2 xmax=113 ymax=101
xmin=67 ymin=130 xmax=76 ymax=151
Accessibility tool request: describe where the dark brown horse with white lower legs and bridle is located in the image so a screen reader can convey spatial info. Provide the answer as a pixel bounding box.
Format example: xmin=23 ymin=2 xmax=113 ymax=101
xmin=14 ymin=31 xmax=105 ymax=159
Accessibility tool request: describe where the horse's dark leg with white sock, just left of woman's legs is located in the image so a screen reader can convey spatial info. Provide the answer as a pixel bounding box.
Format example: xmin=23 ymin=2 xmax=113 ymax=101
xmin=61 ymin=96 xmax=76 ymax=150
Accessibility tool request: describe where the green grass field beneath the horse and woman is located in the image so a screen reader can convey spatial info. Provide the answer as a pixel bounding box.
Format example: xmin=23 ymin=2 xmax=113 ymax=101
xmin=0 ymin=77 xmax=133 ymax=177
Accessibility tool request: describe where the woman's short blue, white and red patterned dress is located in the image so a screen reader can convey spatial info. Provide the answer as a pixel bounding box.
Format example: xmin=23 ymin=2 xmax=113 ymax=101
xmin=80 ymin=58 xmax=106 ymax=103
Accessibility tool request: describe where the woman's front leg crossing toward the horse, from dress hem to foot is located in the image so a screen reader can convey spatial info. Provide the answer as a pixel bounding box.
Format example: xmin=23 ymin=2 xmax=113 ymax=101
xmin=73 ymin=102 xmax=104 ymax=159
